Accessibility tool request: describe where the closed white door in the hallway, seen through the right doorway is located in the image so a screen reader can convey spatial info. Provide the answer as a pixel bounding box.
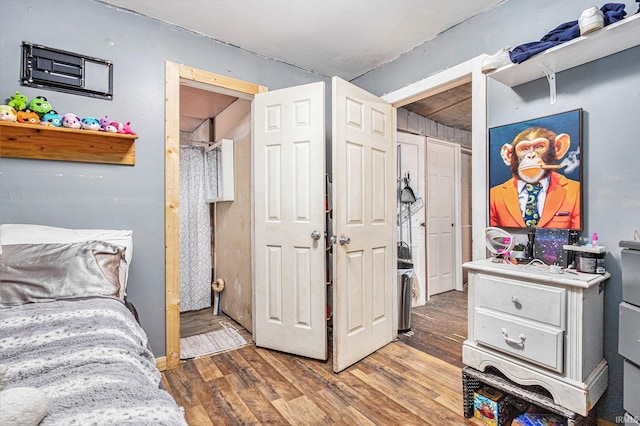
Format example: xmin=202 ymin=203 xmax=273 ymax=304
xmin=427 ymin=138 xmax=460 ymax=296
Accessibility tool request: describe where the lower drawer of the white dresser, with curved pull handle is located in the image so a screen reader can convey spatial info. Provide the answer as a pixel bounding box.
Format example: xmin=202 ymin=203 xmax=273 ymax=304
xmin=473 ymin=308 xmax=564 ymax=373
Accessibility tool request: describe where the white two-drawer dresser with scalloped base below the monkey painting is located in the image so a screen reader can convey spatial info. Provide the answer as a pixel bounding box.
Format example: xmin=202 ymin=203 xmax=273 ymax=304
xmin=462 ymin=259 xmax=610 ymax=416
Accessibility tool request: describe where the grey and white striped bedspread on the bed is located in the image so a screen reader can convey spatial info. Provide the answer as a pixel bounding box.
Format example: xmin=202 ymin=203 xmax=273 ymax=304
xmin=0 ymin=298 xmax=186 ymax=426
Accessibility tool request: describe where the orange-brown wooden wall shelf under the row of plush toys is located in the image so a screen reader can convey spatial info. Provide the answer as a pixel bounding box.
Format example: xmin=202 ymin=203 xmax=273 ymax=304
xmin=0 ymin=121 xmax=138 ymax=166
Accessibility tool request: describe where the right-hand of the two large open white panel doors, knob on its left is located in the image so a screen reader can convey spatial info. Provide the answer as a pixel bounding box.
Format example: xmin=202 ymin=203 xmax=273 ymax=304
xmin=332 ymin=77 xmax=397 ymax=372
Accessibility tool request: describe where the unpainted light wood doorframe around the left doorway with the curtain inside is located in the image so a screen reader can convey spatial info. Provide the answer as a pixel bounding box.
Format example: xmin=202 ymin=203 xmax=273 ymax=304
xmin=165 ymin=61 xmax=269 ymax=370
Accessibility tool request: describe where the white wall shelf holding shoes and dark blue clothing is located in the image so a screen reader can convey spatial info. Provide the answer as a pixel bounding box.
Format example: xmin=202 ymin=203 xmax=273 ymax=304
xmin=487 ymin=14 xmax=640 ymax=87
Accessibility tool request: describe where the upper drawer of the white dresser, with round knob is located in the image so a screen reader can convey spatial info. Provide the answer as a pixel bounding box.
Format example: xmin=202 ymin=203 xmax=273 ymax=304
xmin=473 ymin=274 xmax=567 ymax=330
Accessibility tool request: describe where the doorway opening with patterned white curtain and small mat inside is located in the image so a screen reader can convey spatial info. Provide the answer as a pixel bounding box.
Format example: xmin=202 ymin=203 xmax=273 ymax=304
xmin=179 ymin=84 xmax=252 ymax=359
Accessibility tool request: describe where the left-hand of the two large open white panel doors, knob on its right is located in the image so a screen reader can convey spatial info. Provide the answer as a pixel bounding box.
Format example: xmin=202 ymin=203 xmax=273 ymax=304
xmin=253 ymin=82 xmax=327 ymax=360
